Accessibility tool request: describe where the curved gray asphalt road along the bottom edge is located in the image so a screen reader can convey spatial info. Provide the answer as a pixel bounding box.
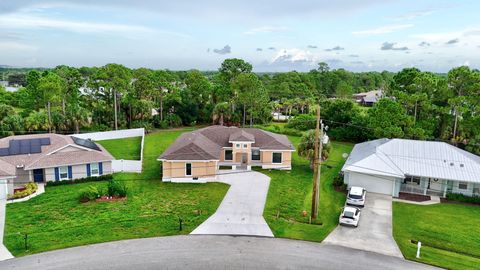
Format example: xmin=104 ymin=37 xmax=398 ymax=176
xmin=0 ymin=235 xmax=433 ymax=270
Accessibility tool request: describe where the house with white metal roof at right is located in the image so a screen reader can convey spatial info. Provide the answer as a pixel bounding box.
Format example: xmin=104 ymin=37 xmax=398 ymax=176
xmin=342 ymin=139 xmax=480 ymax=197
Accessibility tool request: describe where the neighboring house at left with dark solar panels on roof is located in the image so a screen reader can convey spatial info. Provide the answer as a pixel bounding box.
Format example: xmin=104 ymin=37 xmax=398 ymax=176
xmin=0 ymin=134 xmax=114 ymax=198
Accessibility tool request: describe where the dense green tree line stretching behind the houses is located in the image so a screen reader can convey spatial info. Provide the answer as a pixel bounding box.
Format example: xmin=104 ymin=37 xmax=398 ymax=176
xmin=0 ymin=58 xmax=480 ymax=153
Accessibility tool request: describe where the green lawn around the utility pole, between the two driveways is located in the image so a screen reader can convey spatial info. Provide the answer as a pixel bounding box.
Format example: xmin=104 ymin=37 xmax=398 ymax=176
xmin=262 ymin=136 xmax=352 ymax=241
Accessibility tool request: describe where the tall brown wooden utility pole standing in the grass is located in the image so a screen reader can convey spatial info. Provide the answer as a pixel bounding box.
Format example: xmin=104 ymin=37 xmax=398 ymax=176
xmin=311 ymin=105 xmax=323 ymax=220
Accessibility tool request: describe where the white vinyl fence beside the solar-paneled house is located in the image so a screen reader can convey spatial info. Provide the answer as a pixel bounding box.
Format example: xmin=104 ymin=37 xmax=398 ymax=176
xmin=70 ymin=128 xmax=145 ymax=173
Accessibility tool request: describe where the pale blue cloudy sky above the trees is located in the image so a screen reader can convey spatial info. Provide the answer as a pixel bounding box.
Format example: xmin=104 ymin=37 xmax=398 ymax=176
xmin=0 ymin=0 xmax=480 ymax=72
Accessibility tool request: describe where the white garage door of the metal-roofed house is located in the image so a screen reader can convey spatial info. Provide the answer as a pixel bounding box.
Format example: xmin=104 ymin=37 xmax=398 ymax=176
xmin=348 ymin=172 xmax=393 ymax=195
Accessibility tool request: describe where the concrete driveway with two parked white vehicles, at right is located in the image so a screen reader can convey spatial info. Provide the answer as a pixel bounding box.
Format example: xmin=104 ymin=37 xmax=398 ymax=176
xmin=323 ymin=193 xmax=403 ymax=258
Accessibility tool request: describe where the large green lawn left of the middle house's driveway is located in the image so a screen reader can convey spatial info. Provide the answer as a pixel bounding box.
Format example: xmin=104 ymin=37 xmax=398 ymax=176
xmin=4 ymin=130 xmax=228 ymax=256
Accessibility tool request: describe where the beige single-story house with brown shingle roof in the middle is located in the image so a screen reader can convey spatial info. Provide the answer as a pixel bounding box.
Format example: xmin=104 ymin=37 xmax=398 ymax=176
xmin=158 ymin=126 xmax=295 ymax=183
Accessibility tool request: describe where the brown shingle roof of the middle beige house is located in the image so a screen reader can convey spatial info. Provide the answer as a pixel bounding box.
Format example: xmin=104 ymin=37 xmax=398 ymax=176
xmin=159 ymin=126 xmax=295 ymax=160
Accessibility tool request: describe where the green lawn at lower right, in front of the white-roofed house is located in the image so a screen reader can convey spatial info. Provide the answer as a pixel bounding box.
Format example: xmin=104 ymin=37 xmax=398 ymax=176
xmin=393 ymin=202 xmax=480 ymax=269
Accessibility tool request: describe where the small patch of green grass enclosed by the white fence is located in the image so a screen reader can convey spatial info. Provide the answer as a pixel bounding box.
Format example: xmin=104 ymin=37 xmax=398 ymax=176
xmin=96 ymin=137 xmax=142 ymax=160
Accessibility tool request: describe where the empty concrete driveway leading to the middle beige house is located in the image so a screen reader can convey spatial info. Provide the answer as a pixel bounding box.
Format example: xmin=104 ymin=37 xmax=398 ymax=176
xmin=191 ymin=171 xmax=273 ymax=237
